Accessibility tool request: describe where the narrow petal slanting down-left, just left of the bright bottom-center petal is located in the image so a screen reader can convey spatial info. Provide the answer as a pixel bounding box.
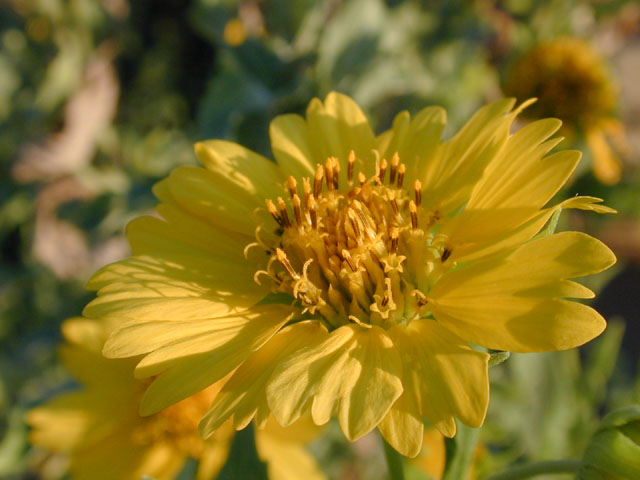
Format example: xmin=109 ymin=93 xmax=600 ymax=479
xmin=200 ymin=321 xmax=326 ymax=438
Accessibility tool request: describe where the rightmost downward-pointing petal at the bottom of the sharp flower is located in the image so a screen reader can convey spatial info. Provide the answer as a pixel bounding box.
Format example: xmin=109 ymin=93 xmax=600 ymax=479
xmin=389 ymin=320 xmax=489 ymax=437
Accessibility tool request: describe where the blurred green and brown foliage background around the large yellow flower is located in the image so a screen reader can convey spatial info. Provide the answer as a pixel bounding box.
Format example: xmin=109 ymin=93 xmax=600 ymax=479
xmin=0 ymin=0 xmax=640 ymax=480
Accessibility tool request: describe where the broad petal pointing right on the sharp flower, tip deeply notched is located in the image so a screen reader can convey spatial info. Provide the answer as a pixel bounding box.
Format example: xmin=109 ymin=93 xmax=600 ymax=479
xmin=429 ymin=232 xmax=615 ymax=352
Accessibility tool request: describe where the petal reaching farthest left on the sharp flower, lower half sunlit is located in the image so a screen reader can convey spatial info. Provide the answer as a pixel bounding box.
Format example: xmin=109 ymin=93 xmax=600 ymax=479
xmin=83 ymin=254 xmax=266 ymax=322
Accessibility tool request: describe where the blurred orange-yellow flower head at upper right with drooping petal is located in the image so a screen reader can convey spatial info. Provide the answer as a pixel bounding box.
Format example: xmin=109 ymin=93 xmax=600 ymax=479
xmin=505 ymin=37 xmax=626 ymax=184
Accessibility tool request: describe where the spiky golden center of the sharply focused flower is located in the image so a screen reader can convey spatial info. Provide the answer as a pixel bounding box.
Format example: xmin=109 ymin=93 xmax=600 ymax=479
xmin=251 ymin=151 xmax=448 ymax=328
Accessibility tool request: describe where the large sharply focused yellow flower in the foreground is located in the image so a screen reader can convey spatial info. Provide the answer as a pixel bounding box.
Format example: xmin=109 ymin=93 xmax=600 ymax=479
xmin=90 ymin=93 xmax=615 ymax=456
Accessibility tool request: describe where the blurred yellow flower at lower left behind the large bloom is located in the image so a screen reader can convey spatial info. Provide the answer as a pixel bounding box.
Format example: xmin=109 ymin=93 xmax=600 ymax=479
xmin=27 ymin=318 xmax=325 ymax=480
